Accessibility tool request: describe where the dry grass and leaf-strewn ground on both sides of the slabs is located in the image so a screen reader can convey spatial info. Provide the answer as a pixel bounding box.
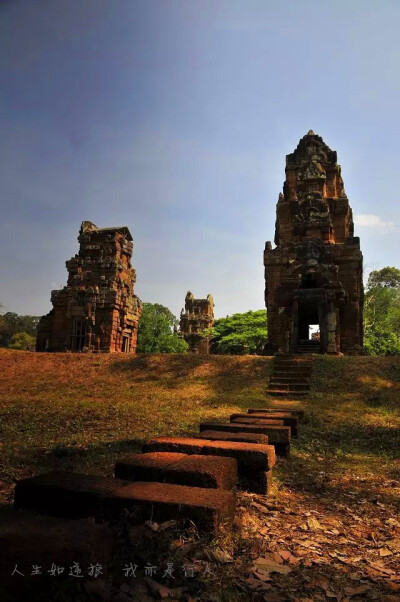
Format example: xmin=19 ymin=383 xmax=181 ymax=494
xmin=0 ymin=350 xmax=400 ymax=602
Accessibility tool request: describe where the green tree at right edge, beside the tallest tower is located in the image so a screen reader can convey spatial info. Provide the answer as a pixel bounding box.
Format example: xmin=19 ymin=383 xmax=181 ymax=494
xmin=364 ymin=267 xmax=400 ymax=355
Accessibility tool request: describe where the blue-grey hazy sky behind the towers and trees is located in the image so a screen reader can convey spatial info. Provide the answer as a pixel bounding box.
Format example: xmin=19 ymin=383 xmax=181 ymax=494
xmin=0 ymin=0 xmax=400 ymax=317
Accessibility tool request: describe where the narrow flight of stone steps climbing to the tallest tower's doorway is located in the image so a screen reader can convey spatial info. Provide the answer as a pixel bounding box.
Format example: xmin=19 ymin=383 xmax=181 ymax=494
xmin=267 ymin=355 xmax=313 ymax=398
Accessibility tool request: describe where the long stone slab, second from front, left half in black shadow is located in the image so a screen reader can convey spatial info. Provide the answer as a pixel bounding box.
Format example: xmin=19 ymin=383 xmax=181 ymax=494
xmin=15 ymin=471 xmax=236 ymax=533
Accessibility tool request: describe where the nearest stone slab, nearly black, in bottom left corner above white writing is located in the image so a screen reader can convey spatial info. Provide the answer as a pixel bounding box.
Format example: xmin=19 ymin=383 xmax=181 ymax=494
xmin=0 ymin=507 xmax=115 ymax=600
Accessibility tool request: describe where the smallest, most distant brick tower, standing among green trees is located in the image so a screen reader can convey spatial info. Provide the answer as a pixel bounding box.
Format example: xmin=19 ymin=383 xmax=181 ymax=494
xmin=180 ymin=291 xmax=214 ymax=353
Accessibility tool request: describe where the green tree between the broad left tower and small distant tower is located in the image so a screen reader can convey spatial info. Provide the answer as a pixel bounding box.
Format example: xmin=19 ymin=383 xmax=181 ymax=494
xmin=136 ymin=303 xmax=188 ymax=353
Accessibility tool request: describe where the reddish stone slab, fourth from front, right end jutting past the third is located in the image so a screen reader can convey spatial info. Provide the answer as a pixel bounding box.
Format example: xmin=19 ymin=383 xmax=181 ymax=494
xmin=143 ymin=431 xmax=276 ymax=495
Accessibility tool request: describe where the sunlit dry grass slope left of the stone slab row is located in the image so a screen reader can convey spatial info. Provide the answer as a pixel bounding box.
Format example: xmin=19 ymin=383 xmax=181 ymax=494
xmin=0 ymin=350 xmax=272 ymax=501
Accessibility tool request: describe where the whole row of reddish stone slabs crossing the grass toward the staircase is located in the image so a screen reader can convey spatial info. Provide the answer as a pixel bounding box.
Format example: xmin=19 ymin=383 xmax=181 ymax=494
xmin=0 ymin=402 xmax=303 ymax=592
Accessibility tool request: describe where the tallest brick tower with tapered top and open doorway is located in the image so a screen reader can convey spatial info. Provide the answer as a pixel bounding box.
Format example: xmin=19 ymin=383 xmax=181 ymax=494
xmin=264 ymin=130 xmax=364 ymax=353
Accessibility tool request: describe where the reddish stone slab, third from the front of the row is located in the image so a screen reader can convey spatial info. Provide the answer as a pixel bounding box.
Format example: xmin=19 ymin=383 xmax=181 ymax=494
xmin=115 ymin=452 xmax=237 ymax=489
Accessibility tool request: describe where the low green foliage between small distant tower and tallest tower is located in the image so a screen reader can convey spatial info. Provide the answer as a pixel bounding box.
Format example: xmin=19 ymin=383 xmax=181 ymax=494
xmin=203 ymin=309 xmax=267 ymax=355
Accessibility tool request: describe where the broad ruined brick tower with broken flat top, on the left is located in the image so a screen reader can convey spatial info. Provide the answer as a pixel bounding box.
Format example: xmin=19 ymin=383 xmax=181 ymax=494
xmin=36 ymin=222 xmax=142 ymax=353
